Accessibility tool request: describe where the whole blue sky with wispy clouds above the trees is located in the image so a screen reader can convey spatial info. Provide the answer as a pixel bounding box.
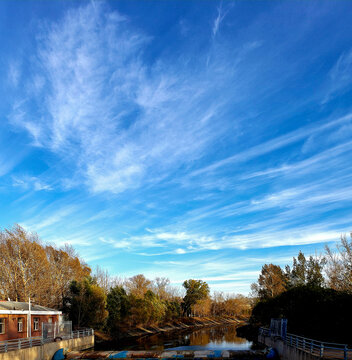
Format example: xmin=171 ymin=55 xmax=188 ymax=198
xmin=0 ymin=1 xmax=352 ymax=294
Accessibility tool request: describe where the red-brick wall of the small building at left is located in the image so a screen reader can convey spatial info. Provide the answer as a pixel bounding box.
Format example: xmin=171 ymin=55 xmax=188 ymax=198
xmin=0 ymin=314 xmax=59 ymax=341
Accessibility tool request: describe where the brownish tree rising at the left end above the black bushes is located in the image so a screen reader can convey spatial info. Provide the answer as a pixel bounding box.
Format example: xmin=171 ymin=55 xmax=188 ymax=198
xmin=251 ymin=264 xmax=287 ymax=299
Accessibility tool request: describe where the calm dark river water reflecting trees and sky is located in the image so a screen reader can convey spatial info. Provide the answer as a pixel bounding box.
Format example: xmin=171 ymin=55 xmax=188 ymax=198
xmin=95 ymin=325 xmax=252 ymax=350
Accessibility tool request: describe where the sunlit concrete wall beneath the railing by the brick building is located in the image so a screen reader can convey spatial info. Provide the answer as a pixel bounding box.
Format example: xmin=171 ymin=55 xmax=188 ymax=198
xmin=0 ymin=335 xmax=94 ymax=360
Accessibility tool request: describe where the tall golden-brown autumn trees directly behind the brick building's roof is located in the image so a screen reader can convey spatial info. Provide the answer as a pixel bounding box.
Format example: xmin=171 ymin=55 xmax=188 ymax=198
xmin=0 ymin=225 xmax=90 ymax=309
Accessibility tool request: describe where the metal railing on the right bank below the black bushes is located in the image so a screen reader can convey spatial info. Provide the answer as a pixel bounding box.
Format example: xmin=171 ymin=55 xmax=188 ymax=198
xmin=259 ymin=328 xmax=352 ymax=360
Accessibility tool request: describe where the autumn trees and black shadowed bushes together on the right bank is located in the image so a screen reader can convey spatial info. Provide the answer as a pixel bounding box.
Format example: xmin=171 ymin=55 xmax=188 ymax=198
xmin=250 ymin=235 xmax=352 ymax=343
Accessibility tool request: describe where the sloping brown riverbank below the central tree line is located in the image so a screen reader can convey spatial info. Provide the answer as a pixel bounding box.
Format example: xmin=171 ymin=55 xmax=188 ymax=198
xmin=95 ymin=317 xmax=246 ymax=343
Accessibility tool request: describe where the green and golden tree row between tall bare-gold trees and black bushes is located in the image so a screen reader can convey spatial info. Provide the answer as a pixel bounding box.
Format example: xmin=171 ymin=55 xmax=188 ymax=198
xmin=63 ymin=269 xmax=250 ymax=337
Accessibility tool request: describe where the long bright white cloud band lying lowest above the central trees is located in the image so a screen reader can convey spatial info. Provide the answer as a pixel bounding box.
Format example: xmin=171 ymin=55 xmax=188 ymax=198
xmin=110 ymin=224 xmax=341 ymax=253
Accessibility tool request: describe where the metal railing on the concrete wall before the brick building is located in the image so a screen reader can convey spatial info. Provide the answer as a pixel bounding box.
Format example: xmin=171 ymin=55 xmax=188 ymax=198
xmin=0 ymin=329 xmax=94 ymax=353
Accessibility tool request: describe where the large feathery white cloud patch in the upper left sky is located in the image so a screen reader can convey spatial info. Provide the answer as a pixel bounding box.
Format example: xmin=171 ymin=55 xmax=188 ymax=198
xmin=11 ymin=4 xmax=236 ymax=193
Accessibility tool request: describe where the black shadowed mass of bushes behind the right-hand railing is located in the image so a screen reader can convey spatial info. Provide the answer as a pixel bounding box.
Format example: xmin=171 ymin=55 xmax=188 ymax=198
xmin=250 ymin=285 xmax=352 ymax=343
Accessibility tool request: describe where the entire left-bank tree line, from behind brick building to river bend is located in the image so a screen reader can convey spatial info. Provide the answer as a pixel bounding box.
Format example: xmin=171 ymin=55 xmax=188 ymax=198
xmin=0 ymin=225 xmax=250 ymax=336
